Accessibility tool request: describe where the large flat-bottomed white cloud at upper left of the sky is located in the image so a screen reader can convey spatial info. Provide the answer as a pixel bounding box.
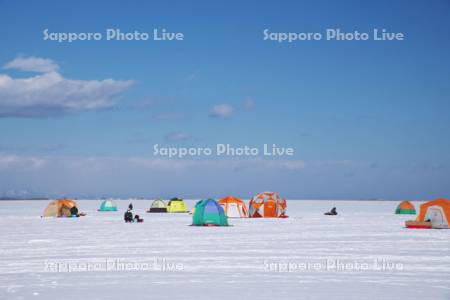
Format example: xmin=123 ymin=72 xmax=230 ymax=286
xmin=0 ymin=58 xmax=133 ymax=117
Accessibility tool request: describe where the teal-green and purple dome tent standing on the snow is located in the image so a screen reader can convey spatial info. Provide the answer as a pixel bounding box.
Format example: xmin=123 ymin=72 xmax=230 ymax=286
xmin=192 ymin=199 xmax=228 ymax=226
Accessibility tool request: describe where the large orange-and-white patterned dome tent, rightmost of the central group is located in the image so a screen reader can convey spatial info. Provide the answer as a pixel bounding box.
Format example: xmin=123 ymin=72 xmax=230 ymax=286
xmin=248 ymin=192 xmax=287 ymax=218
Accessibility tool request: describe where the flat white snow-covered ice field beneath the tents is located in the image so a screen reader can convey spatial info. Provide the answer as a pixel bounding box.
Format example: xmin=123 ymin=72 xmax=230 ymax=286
xmin=0 ymin=200 xmax=450 ymax=300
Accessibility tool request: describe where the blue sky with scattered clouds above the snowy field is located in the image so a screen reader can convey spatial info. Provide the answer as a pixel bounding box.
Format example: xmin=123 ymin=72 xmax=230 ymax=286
xmin=0 ymin=1 xmax=450 ymax=199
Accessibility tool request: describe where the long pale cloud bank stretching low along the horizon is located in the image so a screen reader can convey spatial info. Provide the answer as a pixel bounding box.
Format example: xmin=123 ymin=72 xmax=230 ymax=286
xmin=7 ymin=153 xmax=428 ymax=198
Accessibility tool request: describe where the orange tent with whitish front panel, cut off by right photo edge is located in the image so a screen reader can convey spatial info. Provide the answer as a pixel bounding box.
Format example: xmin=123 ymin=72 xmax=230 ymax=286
xmin=416 ymin=198 xmax=450 ymax=228
